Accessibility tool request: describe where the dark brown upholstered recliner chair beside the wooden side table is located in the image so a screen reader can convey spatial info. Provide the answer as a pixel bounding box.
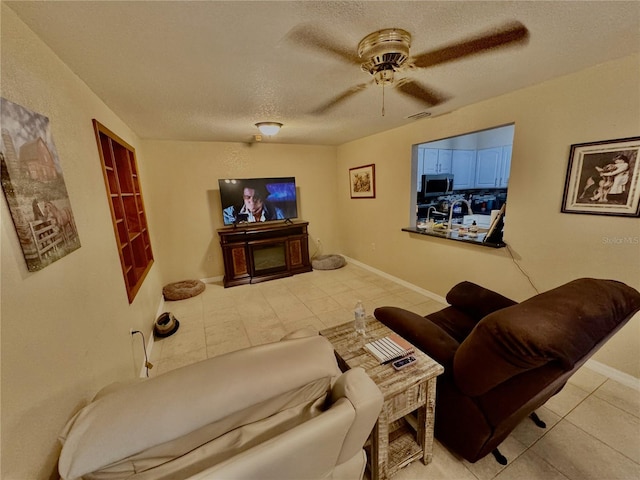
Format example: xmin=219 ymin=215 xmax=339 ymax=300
xmin=374 ymin=278 xmax=640 ymax=464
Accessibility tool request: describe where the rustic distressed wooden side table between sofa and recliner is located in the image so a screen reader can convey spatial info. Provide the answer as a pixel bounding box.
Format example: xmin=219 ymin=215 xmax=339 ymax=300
xmin=320 ymin=316 xmax=444 ymax=480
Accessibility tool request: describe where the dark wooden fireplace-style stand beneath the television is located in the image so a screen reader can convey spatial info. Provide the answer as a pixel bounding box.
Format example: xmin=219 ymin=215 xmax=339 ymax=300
xmin=218 ymin=222 xmax=312 ymax=287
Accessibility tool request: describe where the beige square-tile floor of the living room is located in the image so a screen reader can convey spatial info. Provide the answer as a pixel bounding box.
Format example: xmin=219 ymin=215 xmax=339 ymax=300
xmin=149 ymin=264 xmax=640 ymax=480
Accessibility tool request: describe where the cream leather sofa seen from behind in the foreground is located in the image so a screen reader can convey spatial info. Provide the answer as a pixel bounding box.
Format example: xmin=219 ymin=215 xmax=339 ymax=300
xmin=59 ymin=335 xmax=383 ymax=480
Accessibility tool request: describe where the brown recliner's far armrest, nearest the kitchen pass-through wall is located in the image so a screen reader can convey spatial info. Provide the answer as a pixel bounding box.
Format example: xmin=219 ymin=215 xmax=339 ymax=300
xmin=446 ymin=281 xmax=518 ymax=322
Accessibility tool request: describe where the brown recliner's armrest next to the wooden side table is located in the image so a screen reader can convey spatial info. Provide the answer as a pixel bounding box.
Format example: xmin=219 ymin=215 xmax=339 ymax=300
xmin=373 ymin=307 xmax=460 ymax=372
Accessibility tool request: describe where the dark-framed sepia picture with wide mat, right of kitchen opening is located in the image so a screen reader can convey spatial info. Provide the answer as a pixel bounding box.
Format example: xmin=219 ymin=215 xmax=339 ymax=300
xmin=562 ymin=137 xmax=640 ymax=217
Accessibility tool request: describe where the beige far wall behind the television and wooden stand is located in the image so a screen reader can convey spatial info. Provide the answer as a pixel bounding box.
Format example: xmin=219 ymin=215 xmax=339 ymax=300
xmin=142 ymin=141 xmax=338 ymax=283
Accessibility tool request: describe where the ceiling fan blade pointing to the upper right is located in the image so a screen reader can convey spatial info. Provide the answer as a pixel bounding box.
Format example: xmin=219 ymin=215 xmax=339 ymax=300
xmin=412 ymin=22 xmax=529 ymax=68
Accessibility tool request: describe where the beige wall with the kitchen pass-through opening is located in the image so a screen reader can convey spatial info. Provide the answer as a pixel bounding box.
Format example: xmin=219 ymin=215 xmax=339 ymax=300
xmin=337 ymin=56 xmax=640 ymax=377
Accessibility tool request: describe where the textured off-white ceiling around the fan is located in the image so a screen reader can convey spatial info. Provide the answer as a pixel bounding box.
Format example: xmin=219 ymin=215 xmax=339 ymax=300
xmin=5 ymin=1 xmax=640 ymax=145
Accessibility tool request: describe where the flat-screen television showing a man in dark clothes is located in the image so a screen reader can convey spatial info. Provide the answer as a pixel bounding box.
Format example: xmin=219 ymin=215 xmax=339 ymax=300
xmin=218 ymin=177 xmax=298 ymax=225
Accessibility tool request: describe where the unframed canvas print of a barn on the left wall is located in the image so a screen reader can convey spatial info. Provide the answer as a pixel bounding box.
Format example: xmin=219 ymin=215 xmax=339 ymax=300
xmin=0 ymin=98 xmax=80 ymax=272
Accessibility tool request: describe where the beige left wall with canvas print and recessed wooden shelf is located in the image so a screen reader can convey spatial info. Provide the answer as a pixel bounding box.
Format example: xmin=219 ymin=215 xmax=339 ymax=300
xmin=0 ymin=4 xmax=161 ymax=480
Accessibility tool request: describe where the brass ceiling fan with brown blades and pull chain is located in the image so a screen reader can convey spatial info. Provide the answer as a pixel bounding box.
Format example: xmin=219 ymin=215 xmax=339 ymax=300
xmin=289 ymin=21 xmax=529 ymax=115
